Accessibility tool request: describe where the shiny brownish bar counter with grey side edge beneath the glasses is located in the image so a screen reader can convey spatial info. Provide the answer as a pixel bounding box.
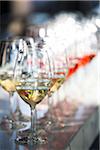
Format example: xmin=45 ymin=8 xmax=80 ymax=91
xmin=0 ymin=102 xmax=100 ymax=150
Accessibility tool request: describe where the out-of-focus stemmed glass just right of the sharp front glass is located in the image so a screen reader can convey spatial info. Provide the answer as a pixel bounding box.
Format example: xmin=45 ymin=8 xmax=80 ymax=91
xmin=36 ymin=39 xmax=68 ymax=130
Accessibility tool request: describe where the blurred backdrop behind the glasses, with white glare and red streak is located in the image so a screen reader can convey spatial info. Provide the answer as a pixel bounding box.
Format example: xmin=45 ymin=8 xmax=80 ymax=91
xmin=0 ymin=0 xmax=100 ymax=149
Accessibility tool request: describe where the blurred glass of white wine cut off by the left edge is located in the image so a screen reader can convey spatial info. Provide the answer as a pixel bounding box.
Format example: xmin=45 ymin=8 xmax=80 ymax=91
xmin=0 ymin=38 xmax=29 ymax=129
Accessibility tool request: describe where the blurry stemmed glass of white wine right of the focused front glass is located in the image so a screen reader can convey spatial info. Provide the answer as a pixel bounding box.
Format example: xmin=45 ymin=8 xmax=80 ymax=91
xmin=48 ymin=54 xmax=67 ymax=129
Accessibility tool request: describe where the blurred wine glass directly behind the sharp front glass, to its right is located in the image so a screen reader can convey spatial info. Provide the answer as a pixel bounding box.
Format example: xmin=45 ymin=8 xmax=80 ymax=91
xmin=49 ymin=59 xmax=67 ymax=129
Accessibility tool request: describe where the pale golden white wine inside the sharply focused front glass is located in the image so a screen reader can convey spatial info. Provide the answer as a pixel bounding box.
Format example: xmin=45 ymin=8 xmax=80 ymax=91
xmin=16 ymin=80 xmax=49 ymax=107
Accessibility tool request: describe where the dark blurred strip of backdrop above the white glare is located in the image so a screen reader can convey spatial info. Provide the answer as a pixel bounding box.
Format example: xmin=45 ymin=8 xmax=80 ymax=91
xmin=0 ymin=0 xmax=99 ymax=39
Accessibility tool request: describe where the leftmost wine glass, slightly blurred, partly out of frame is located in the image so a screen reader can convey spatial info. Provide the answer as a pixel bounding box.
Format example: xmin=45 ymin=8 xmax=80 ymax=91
xmin=0 ymin=39 xmax=23 ymax=129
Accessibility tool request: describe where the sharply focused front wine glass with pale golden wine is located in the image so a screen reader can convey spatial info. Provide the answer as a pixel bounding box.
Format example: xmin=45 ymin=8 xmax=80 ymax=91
xmin=14 ymin=40 xmax=50 ymax=144
